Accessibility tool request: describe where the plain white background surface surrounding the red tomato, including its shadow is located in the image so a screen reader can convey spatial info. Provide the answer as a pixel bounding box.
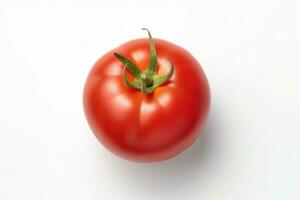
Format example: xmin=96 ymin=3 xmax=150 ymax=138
xmin=0 ymin=0 xmax=300 ymax=200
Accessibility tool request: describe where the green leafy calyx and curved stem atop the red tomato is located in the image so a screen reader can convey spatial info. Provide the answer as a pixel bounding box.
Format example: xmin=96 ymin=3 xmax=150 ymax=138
xmin=114 ymin=28 xmax=174 ymax=94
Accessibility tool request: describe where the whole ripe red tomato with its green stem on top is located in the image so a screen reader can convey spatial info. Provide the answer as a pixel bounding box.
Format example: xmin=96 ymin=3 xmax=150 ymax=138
xmin=83 ymin=29 xmax=210 ymax=162
